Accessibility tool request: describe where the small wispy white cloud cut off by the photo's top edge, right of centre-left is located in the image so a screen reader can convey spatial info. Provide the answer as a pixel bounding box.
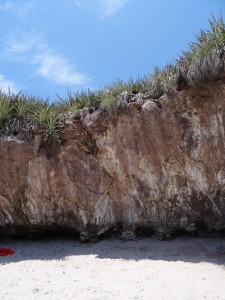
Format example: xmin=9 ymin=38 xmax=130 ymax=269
xmin=75 ymin=0 xmax=130 ymax=19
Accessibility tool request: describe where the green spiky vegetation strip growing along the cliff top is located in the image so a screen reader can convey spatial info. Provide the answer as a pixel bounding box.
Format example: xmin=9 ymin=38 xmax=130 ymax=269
xmin=0 ymin=16 xmax=225 ymax=142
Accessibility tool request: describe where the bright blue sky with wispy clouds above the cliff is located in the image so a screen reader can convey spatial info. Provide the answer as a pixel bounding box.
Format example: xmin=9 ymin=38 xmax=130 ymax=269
xmin=0 ymin=0 xmax=225 ymax=101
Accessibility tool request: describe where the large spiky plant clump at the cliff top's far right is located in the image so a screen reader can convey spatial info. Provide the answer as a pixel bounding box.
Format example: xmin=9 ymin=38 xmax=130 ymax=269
xmin=177 ymin=15 xmax=225 ymax=85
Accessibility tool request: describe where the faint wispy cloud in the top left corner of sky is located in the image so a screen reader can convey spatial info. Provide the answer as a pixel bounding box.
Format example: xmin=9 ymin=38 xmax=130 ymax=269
xmin=0 ymin=0 xmax=36 ymax=19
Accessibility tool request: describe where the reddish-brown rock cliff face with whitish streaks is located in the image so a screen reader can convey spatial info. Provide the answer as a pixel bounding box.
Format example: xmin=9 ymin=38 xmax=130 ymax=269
xmin=0 ymin=82 xmax=225 ymax=238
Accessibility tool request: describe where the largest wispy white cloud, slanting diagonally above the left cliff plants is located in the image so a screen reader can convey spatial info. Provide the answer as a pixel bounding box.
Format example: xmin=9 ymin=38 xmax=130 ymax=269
xmin=5 ymin=32 xmax=89 ymax=85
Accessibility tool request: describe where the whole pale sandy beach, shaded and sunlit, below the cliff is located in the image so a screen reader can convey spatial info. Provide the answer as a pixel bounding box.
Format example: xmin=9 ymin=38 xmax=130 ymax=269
xmin=0 ymin=237 xmax=225 ymax=300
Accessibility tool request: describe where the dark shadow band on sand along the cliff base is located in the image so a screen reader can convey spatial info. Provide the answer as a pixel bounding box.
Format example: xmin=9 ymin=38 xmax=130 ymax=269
xmin=0 ymin=236 xmax=225 ymax=267
